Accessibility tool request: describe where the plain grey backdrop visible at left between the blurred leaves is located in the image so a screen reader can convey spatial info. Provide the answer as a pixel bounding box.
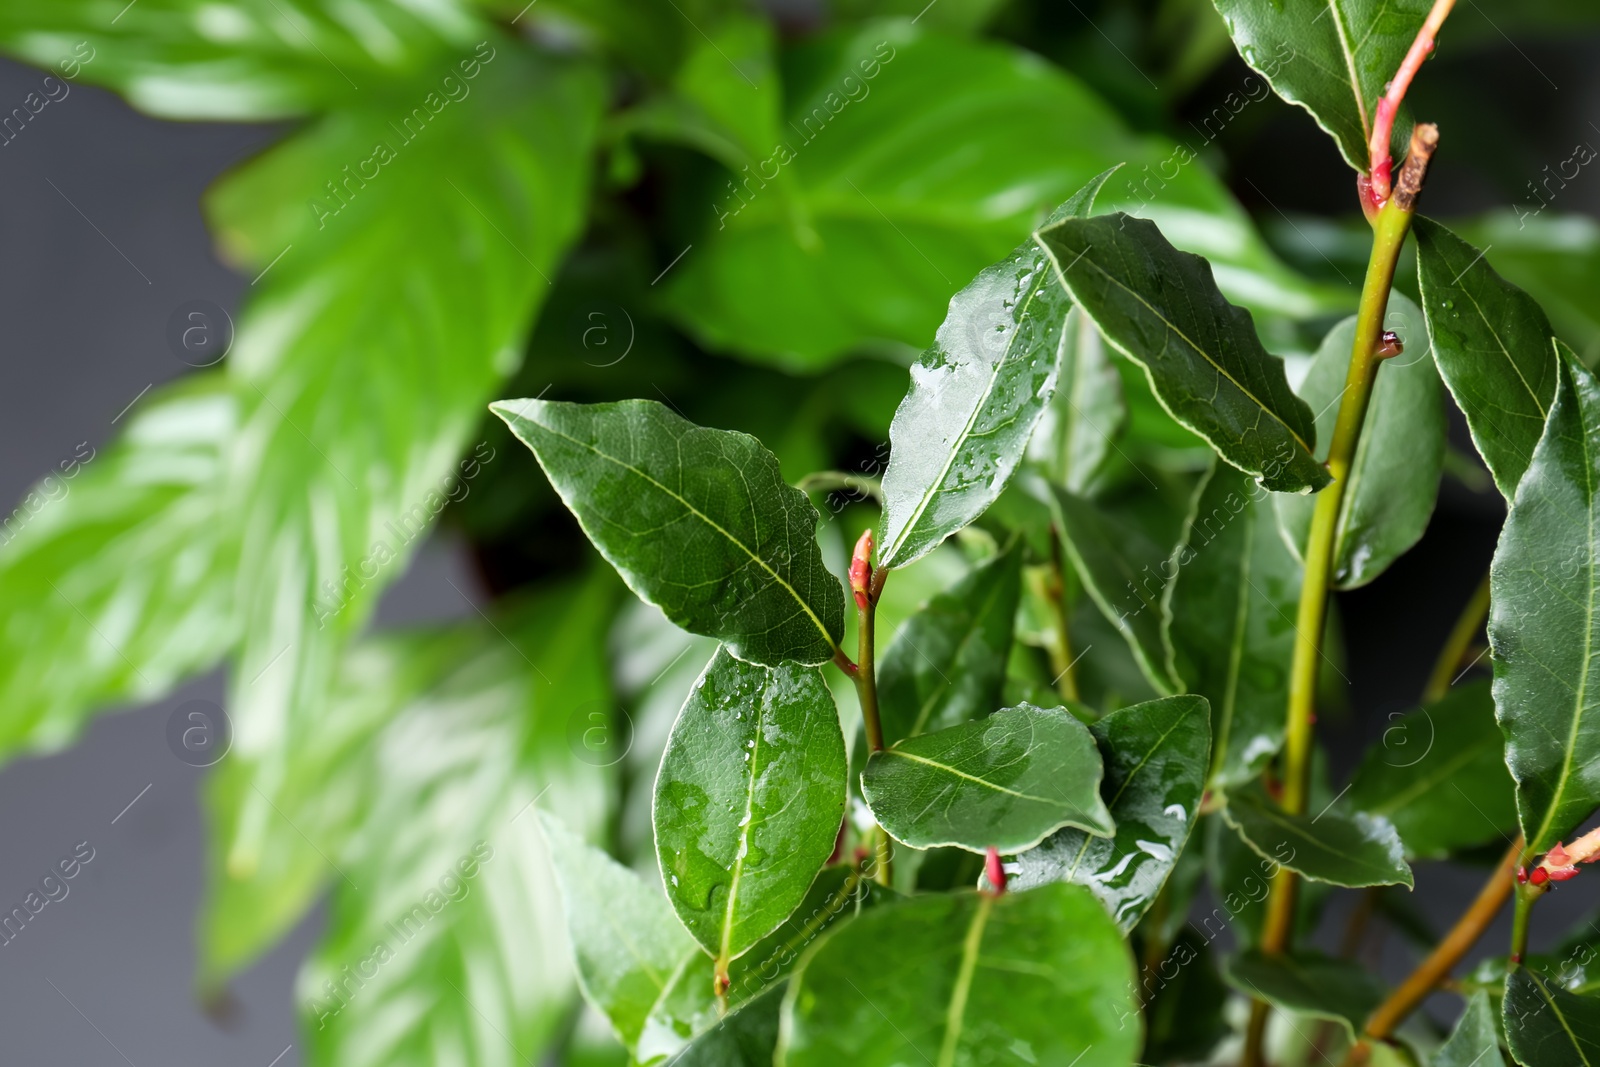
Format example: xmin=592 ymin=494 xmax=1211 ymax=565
xmin=0 ymin=61 xmax=475 ymax=1067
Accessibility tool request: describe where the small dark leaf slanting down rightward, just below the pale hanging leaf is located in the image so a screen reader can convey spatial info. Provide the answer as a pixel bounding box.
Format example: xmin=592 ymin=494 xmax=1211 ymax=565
xmin=1051 ymin=486 xmax=1178 ymax=693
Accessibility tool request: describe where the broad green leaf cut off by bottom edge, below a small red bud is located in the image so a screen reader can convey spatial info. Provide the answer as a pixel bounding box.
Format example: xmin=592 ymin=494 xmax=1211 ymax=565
xmin=773 ymin=883 xmax=1142 ymax=1067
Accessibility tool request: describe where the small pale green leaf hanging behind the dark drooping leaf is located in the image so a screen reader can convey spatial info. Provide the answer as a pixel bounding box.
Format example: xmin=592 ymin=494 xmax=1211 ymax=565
xmin=1027 ymin=307 xmax=1128 ymax=494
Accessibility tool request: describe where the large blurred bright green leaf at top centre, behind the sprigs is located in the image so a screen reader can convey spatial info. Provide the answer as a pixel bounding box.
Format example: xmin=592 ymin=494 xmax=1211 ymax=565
xmin=659 ymin=21 xmax=1349 ymax=371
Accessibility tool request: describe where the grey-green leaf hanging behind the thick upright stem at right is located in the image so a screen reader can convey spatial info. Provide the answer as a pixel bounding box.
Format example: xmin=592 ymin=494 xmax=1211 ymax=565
xmin=1277 ymin=293 xmax=1448 ymax=589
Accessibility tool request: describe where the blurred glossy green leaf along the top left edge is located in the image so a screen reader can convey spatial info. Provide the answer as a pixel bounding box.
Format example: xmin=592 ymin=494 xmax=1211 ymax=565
xmin=0 ymin=0 xmax=492 ymax=120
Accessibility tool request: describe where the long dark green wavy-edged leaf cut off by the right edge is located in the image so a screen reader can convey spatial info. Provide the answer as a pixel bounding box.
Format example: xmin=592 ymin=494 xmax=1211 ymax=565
xmin=1490 ymin=357 xmax=1600 ymax=853
